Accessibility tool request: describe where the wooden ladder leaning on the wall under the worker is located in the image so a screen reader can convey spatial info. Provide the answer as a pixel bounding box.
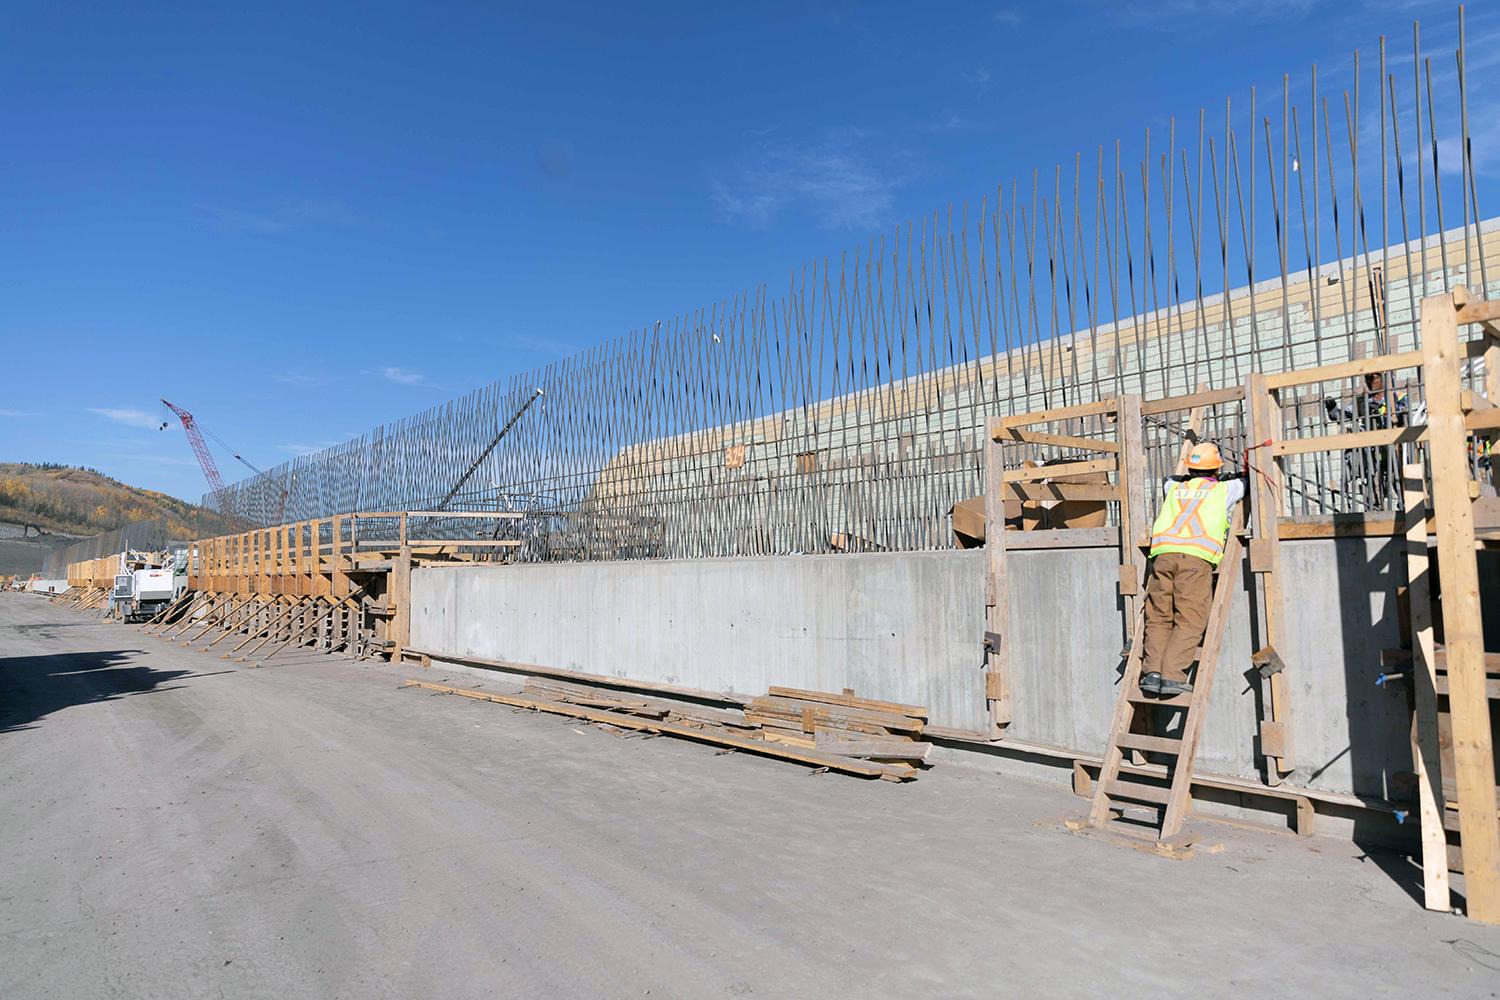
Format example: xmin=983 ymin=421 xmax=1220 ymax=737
xmin=1089 ymin=515 xmax=1244 ymax=841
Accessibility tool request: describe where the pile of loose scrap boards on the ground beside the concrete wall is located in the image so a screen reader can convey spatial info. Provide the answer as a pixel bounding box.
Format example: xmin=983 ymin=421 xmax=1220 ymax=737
xmin=407 ymin=676 xmax=932 ymax=781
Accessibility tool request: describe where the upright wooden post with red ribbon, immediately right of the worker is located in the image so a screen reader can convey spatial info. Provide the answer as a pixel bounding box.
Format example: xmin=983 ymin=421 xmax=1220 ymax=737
xmin=1245 ymin=373 xmax=1296 ymax=784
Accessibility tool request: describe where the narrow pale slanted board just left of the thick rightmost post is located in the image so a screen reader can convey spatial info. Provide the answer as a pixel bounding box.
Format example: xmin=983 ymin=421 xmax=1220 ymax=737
xmin=1401 ymin=463 xmax=1452 ymax=913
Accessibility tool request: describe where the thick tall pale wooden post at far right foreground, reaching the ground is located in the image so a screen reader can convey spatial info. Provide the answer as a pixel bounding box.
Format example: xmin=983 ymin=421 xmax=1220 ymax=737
xmin=1422 ymin=295 xmax=1500 ymax=924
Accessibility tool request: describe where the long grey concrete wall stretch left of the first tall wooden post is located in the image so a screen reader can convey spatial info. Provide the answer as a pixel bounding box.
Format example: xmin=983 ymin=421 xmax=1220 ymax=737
xmin=411 ymin=552 xmax=986 ymax=729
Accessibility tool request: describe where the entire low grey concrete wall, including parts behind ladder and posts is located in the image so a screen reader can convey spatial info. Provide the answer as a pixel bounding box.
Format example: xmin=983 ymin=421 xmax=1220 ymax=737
xmin=411 ymin=538 xmax=1470 ymax=798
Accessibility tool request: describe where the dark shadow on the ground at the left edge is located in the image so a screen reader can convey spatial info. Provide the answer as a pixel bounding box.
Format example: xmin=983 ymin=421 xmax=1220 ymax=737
xmin=0 ymin=649 xmax=204 ymax=733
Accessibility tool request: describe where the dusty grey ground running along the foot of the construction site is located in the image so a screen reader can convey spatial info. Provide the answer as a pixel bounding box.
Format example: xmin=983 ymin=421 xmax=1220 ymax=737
xmin=0 ymin=594 xmax=1500 ymax=1000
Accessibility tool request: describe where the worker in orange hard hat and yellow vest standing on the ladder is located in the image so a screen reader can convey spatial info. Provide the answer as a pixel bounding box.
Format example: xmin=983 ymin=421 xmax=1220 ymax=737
xmin=1140 ymin=444 xmax=1245 ymax=697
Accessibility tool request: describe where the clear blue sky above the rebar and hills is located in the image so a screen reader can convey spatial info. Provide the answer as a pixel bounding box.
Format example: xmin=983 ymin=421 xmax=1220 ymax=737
xmin=0 ymin=0 xmax=1482 ymax=499
